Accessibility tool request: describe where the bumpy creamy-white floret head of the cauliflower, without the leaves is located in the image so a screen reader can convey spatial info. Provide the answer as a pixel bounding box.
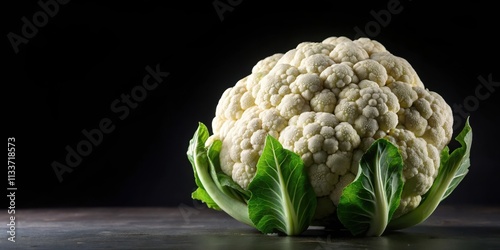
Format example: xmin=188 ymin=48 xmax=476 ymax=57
xmin=207 ymin=36 xmax=453 ymax=218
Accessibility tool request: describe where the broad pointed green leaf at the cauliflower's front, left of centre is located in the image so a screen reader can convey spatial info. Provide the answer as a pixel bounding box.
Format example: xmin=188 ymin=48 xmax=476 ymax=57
xmin=248 ymin=135 xmax=316 ymax=236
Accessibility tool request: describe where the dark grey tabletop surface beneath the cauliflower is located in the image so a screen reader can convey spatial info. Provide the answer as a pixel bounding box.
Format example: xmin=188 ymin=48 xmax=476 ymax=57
xmin=0 ymin=205 xmax=500 ymax=250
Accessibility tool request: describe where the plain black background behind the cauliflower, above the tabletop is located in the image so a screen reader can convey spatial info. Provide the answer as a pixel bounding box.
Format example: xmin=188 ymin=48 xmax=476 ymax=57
xmin=0 ymin=0 xmax=500 ymax=208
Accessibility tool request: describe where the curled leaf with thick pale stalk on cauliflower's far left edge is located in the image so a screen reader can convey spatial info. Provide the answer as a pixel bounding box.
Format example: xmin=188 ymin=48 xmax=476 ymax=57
xmin=187 ymin=122 xmax=253 ymax=227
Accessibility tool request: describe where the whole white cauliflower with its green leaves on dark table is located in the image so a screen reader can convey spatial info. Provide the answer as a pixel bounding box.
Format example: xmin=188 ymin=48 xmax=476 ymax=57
xmin=187 ymin=36 xmax=472 ymax=236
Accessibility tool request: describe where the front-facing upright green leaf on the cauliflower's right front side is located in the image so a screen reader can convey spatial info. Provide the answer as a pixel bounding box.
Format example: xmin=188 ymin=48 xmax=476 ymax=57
xmin=337 ymin=139 xmax=404 ymax=236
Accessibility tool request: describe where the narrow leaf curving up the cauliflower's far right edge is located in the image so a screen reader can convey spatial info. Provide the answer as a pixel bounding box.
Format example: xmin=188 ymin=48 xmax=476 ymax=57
xmin=388 ymin=117 xmax=472 ymax=230
